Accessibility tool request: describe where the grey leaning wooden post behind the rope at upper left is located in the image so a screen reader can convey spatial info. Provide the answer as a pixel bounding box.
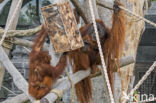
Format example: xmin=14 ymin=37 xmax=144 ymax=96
xmin=0 ymin=0 xmax=23 ymax=88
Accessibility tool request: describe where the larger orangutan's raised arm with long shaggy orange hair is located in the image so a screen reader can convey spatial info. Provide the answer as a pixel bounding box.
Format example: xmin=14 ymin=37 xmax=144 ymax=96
xmin=103 ymin=2 xmax=125 ymax=90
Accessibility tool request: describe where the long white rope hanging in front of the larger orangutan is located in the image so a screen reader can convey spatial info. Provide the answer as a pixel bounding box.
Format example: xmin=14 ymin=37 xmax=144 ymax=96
xmin=89 ymin=0 xmax=114 ymax=103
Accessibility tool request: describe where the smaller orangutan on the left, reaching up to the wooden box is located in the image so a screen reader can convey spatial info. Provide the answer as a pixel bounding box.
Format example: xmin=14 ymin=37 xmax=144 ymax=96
xmin=29 ymin=26 xmax=66 ymax=99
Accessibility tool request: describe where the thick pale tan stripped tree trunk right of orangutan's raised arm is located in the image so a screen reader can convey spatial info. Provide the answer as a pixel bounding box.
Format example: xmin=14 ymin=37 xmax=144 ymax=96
xmin=120 ymin=0 xmax=144 ymax=101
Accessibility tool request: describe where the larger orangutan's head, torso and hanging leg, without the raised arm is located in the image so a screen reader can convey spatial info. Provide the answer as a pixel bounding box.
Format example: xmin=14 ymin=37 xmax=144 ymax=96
xmin=69 ymin=20 xmax=110 ymax=103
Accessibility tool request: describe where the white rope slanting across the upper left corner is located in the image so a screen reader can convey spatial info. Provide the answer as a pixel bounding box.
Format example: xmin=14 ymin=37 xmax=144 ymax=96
xmin=0 ymin=0 xmax=22 ymax=46
